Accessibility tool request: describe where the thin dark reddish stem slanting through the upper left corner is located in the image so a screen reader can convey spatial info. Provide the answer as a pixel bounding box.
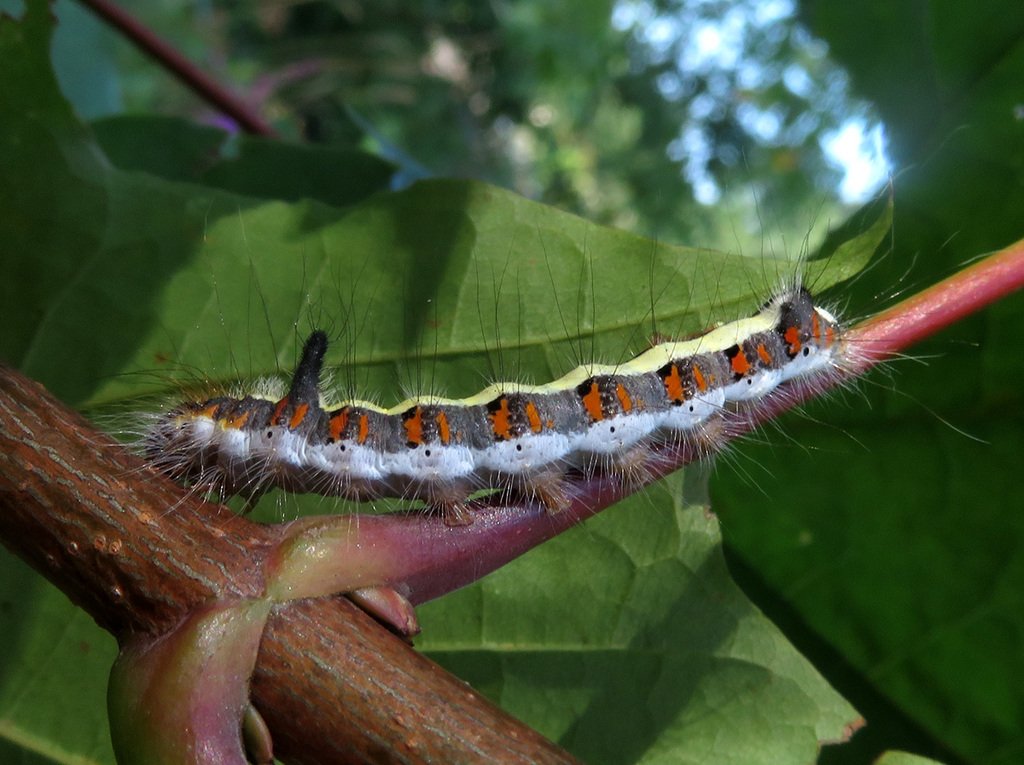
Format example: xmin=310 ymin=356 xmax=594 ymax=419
xmin=79 ymin=0 xmax=275 ymax=136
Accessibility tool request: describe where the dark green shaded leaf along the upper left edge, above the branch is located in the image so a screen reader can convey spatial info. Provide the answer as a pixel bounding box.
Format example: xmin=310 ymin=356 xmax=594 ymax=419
xmin=0 ymin=0 xmax=106 ymax=374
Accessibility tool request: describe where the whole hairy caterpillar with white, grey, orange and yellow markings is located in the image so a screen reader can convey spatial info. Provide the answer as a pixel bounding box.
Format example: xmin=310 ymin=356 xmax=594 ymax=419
xmin=143 ymin=286 xmax=843 ymax=523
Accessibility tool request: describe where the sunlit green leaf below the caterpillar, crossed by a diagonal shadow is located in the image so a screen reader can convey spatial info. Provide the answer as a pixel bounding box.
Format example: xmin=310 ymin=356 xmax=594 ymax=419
xmin=419 ymin=471 xmax=857 ymax=764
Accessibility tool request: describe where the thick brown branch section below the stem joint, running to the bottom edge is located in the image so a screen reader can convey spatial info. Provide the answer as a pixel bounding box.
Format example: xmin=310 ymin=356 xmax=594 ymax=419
xmin=252 ymin=598 xmax=575 ymax=765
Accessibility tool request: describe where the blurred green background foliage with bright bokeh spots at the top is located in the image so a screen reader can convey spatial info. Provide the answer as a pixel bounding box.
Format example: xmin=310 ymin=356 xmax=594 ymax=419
xmin=49 ymin=0 xmax=871 ymax=245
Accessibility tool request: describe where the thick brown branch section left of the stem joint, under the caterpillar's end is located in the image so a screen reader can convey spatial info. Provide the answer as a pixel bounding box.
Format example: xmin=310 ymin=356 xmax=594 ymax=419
xmin=0 ymin=367 xmax=273 ymax=636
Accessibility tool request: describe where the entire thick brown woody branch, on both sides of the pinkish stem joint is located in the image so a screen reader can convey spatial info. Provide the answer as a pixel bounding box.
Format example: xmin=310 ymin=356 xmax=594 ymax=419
xmin=0 ymin=366 xmax=573 ymax=765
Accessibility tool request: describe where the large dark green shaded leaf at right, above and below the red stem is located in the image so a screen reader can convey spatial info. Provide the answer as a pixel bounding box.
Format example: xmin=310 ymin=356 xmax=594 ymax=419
xmin=712 ymin=2 xmax=1024 ymax=765
